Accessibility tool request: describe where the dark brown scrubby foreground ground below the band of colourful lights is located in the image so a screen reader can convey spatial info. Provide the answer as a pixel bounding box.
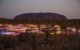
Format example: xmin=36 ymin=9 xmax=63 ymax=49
xmin=0 ymin=33 xmax=80 ymax=50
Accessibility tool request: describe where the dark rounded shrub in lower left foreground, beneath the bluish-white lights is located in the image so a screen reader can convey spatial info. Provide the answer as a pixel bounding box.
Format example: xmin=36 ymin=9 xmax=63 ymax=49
xmin=1 ymin=36 xmax=19 ymax=49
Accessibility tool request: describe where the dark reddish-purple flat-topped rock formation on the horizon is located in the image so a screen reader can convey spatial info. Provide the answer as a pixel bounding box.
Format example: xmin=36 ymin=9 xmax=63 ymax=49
xmin=14 ymin=13 xmax=67 ymax=20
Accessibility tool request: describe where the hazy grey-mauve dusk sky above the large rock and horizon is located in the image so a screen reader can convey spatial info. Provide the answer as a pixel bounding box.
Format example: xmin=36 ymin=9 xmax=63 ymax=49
xmin=0 ymin=0 xmax=80 ymax=19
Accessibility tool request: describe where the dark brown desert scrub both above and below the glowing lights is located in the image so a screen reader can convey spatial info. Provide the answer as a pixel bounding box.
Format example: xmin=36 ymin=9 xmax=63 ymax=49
xmin=0 ymin=19 xmax=80 ymax=50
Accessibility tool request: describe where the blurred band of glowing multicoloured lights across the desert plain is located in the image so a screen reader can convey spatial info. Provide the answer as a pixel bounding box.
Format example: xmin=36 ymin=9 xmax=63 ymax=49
xmin=0 ymin=24 xmax=80 ymax=35
